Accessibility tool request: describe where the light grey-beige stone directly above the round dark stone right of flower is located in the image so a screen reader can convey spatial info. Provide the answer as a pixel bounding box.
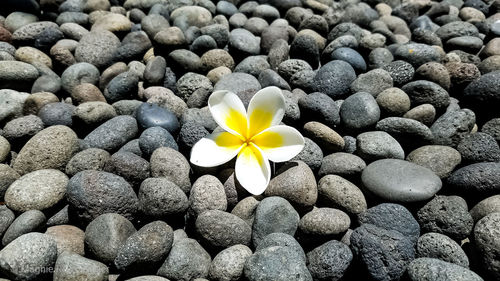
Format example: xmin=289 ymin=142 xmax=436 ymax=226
xmin=350 ymin=68 xmax=393 ymax=97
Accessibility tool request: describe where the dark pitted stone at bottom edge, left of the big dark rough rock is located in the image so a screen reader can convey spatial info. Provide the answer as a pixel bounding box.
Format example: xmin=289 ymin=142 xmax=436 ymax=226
xmin=307 ymin=240 xmax=353 ymax=280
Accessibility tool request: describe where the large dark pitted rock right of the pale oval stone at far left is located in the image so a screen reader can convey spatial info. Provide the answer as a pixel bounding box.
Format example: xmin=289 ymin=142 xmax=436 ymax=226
xmin=67 ymin=170 xmax=139 ymax=223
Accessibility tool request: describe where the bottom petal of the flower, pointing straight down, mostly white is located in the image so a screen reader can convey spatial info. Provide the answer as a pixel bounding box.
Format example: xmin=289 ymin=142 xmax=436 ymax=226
xmin=235 ymin=144 xmax=271 ymax=195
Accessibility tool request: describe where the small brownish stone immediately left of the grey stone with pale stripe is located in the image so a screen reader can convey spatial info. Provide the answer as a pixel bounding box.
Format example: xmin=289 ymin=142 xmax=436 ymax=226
xmin=45 ymin=224 xmax=85 ymax=256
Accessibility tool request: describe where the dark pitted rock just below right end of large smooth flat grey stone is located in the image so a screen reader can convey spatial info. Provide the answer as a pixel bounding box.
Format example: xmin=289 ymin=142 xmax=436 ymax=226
xmin=417 ymin=195 xmax=474 ymax=241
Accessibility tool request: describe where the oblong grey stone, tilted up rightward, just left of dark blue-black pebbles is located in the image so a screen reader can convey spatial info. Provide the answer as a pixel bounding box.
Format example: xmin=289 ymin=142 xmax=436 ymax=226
xmin=83 ymin=115 xmax=139 ymax=152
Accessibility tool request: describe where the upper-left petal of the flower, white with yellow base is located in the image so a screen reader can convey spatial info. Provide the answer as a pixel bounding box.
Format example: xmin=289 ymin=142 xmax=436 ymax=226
xmin=208 ymin=91 xmax=248 ymax=137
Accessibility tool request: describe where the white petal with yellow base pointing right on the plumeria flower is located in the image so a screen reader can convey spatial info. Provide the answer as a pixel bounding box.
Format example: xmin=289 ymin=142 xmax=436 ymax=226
xmin=252 ymin=125 xmax=304 ymax=162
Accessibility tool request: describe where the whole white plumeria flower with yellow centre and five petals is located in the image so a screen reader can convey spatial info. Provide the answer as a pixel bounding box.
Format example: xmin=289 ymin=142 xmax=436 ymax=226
xmin=191 ymin=87 xmax=304 ymax=195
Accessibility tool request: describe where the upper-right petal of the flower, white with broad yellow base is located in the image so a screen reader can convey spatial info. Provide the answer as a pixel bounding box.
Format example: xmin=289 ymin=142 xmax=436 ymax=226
xmin=248 ymin=86 xmax=285 ymax=137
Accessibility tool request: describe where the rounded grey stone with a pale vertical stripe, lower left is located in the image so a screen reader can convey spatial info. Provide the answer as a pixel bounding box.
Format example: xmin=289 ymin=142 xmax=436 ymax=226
xmin=85 ymin=213 xmax=136 ymax=264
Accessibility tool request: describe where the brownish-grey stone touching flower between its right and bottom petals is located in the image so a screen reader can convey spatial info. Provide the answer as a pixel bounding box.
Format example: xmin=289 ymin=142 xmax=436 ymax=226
xmin=264 ymin=161 xmax=318 ymax=208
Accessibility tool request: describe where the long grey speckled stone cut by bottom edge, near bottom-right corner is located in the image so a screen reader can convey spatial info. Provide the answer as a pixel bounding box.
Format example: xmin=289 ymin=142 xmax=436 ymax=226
xmin=407 ymin=258 xmax=483 ymax=281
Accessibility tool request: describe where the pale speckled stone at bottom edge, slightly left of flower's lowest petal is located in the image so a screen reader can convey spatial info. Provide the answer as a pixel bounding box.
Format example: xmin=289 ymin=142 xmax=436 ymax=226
xmin=208 ymin=243 xmax=252 ymax=280
